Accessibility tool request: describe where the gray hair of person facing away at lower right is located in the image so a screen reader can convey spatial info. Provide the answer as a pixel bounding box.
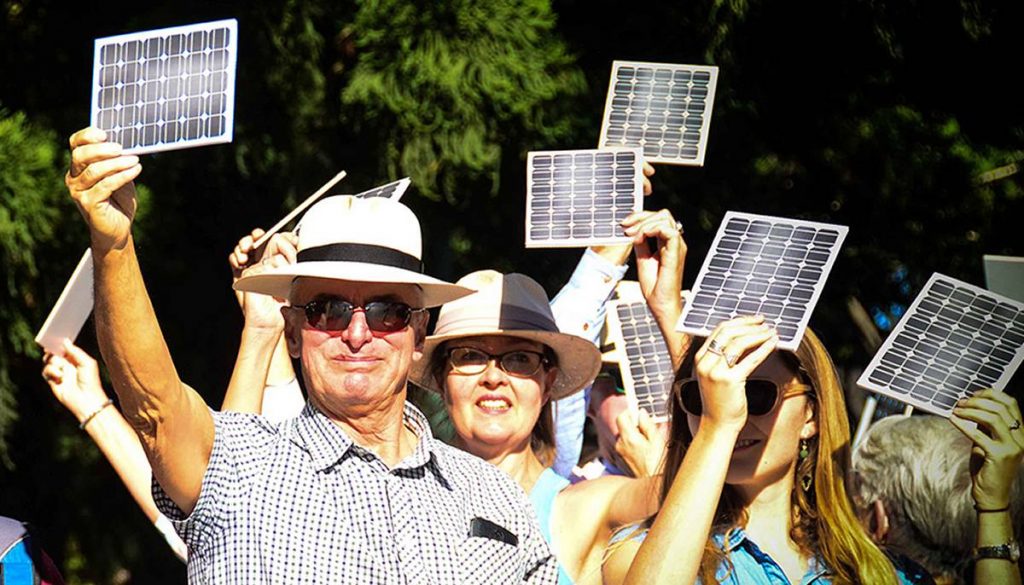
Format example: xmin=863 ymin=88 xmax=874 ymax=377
xmin=850 ymin=415 xmax=1024 ymax=583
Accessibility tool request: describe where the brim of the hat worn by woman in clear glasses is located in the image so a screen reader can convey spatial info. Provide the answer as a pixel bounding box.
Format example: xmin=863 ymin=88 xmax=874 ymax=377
xmin=409 ymin=328 xmax=601 ymax=401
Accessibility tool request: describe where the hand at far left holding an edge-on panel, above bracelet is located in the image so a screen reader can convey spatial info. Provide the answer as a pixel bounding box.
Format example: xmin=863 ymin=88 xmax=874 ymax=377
xmin=43 ymin=340 xmax=108 ymax=423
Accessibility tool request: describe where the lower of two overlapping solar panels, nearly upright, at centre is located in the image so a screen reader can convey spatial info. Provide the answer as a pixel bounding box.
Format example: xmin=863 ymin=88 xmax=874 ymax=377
xmin=526 ymin=148 xmax=643 ymax=248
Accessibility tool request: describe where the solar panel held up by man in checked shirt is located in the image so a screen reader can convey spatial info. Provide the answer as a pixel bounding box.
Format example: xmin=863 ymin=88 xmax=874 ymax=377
xmin=90 ymin=18 xmax=238 ymax=154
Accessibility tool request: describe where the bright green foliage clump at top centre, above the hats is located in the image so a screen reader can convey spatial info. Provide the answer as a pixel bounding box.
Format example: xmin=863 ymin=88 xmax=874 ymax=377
xmin=341 ymin=0 xmax=584 ymax=204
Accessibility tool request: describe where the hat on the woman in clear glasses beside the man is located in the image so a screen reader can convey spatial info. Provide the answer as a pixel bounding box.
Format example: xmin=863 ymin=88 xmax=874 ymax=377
xmin=410 ymin=270 xmax=601 ymax=400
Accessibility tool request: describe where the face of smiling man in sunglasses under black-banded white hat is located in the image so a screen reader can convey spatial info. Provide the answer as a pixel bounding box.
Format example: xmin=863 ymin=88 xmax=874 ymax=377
xmin=285 ymin=278 xmax=427 ymax=417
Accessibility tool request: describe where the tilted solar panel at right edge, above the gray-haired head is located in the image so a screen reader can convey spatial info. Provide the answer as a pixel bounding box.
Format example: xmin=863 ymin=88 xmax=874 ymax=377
xmin=857 ymin=273 xmax=1024 ymax=416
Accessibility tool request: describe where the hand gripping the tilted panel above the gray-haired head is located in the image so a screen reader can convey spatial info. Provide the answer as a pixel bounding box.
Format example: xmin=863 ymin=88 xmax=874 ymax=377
xmin=949 ymin=389 xmax=1024 ymax=510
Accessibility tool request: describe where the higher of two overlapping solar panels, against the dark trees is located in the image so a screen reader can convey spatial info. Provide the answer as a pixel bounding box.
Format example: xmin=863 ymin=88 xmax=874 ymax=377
xmin=598 ymin=60 xmax=718 ymax=166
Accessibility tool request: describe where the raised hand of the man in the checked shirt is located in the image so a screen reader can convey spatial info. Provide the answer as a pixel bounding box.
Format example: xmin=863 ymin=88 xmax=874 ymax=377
xmin=65 ymin=127 xmax=142 ymax=251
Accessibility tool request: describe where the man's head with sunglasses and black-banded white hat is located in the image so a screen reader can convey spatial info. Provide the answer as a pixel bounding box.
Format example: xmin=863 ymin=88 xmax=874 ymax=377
xmin=234 ymin=196 xmax=471 ymax=416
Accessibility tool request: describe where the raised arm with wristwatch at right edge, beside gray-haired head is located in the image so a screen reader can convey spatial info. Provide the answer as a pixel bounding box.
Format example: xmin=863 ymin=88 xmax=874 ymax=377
xmin=949 ymin=389 xmax=1024 ymax=585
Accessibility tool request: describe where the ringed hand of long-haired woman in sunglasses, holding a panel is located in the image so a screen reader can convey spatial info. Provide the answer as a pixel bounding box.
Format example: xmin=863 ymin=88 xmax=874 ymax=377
xmin=694 ymin=317 xmax=778 ymax=427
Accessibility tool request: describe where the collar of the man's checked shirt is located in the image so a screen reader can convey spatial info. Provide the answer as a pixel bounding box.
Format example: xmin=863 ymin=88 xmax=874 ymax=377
xmin=293 ymin=402 xmax=435 ymax=471
